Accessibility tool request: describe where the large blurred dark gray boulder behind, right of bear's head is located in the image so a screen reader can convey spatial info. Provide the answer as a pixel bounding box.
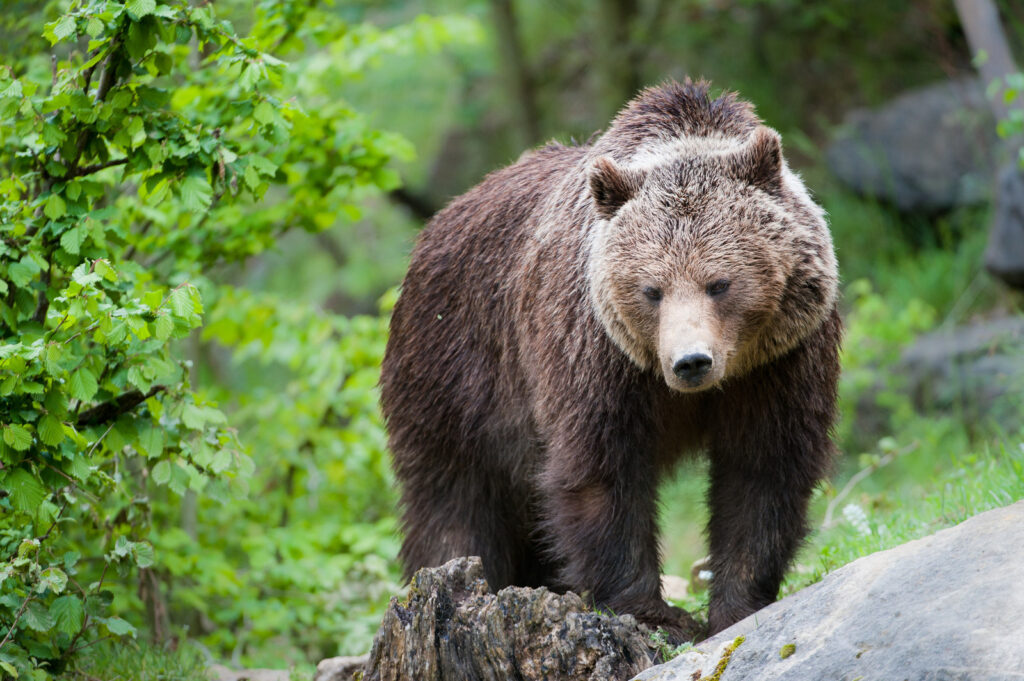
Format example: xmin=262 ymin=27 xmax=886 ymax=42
xmin=825 ymin=78 xmax=1000 ymax=213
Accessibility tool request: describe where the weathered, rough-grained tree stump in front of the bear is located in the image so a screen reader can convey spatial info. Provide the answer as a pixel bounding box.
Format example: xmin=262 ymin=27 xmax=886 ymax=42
xmin=364 ymin=558 xmax=654 ymax=681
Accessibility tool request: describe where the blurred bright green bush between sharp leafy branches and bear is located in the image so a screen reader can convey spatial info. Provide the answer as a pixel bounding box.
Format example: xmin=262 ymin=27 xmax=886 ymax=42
xmin=154 ymin=287 xmax=400 ymax=666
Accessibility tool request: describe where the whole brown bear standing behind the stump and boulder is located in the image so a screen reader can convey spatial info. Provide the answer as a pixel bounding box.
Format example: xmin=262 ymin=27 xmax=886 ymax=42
xmin=381 ymin=80 xmax=842 ymax=638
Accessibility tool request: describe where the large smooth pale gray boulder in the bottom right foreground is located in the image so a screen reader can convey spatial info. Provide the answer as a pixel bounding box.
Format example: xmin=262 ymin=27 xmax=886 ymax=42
xmin=635 ymin=502 xmax=1024 ymax=681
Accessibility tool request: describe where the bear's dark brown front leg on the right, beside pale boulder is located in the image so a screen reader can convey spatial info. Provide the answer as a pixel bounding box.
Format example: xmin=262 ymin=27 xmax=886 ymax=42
xmin=708 ymin=314 xmax=840 ymax=635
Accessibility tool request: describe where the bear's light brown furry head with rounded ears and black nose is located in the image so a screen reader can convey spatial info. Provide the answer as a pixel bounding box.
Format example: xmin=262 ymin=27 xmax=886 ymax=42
xmin=589 ymin=125 xmax=838 ymax=392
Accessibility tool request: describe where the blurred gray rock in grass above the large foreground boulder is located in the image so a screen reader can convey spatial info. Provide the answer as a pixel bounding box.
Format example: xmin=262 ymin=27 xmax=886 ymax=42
xmin=897 ymin=317 xmax=1024 ymax=432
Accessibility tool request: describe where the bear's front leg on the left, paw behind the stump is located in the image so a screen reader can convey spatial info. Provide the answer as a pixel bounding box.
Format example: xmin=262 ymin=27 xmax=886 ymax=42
xmin=541 ymin=415 xmax=699 ymax=643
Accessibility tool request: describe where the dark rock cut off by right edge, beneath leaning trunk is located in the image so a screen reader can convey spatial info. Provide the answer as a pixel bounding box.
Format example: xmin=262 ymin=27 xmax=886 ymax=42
xmin=985 ymin=163 xmax=1024 ymax=289
